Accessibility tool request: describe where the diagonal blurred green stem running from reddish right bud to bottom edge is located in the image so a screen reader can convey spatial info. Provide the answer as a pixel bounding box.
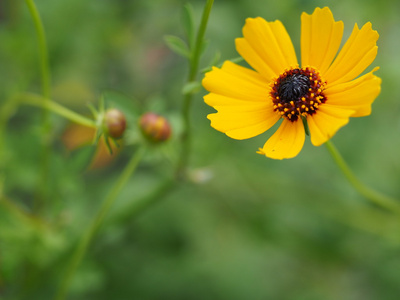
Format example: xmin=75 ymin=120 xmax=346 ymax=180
xmin=55 ymin=148 xmax=145 ymax=300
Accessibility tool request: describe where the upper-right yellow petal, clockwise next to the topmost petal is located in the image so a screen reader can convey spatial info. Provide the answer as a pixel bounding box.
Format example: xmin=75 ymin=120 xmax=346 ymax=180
xmin=324 ymin=22 xmax=379 ymax=85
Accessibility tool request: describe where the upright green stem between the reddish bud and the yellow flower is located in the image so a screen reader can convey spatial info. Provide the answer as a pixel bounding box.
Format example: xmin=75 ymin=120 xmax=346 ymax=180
xmin=177 ymin=0 xmax=214 ymax=177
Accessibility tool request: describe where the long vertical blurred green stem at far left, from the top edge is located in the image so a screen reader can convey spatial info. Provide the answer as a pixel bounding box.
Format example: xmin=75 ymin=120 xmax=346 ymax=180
xmin=25 ymin=0 xmax=51 ymax=210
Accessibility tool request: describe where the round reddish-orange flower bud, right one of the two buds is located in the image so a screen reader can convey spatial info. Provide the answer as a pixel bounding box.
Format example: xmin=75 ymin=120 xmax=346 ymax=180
xmin=139 ymin=112 xmax=171 ymax=143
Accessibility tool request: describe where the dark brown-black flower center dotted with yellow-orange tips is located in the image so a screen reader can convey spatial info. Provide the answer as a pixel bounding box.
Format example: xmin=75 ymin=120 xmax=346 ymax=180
xmin=270 ymin=67 xmax=326 ymax=122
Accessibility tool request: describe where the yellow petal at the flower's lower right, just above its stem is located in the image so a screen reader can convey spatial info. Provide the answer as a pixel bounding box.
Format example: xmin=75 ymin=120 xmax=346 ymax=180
xmin=307 ymin=103 xmax=354 ymax=146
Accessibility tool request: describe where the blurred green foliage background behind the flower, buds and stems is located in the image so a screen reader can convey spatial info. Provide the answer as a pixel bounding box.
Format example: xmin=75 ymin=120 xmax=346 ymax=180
xmin=0 ymin=0 xmax=400 ymax=300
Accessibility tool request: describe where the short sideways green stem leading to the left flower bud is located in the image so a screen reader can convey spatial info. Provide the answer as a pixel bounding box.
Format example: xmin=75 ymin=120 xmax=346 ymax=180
xmin=18 ymin=93 xmax=97 ymax=128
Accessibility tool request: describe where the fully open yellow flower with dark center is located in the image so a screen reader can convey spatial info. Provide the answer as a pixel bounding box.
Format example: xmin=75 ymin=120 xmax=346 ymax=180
xmin=203 ymin=7 xmax=381 ymax=159
